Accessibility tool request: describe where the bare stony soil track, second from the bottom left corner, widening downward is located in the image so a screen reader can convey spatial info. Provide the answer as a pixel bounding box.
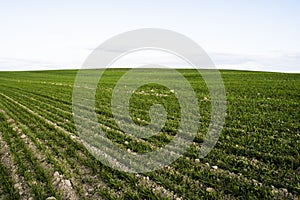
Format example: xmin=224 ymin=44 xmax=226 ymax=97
xmin=0 ymin=109 xmax=79 ymax=200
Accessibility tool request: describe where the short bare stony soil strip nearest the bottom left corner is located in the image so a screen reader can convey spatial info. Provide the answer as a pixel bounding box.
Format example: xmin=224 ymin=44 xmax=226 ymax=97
xmin=0 ymin=122 xmax=33 ymax=200
